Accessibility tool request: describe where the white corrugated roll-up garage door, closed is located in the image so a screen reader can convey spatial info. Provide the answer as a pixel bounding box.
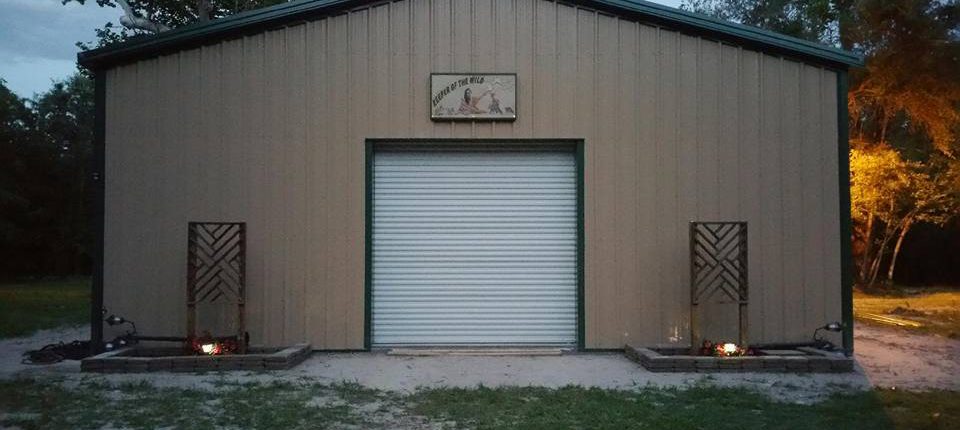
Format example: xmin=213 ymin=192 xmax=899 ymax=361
xmin=372 ymin=151 xmax=577 ymax=346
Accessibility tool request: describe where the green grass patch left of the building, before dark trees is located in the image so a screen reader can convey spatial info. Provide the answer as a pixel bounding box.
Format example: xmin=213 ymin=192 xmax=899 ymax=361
xmin=0 ymin=278 xmax=90 ymax=338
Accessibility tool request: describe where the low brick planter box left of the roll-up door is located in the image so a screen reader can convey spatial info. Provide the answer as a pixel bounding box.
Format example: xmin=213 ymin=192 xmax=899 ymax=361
xmin=80 ymin=343 xmax=311 ymax=373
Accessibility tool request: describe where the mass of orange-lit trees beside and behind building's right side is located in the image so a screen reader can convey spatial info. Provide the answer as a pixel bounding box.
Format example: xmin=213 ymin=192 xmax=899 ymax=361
xmin=684 ymin=0 xmax=960 ymax=284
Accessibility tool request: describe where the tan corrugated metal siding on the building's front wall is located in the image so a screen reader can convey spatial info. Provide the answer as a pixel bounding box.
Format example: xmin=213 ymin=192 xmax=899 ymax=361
xmin=105 ymin=0 xmax=840 ymax=349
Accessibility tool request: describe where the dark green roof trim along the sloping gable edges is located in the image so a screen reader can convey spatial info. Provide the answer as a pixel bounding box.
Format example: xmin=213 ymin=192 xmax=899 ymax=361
xmin=77 ymin=0 xmax=863 ymax=70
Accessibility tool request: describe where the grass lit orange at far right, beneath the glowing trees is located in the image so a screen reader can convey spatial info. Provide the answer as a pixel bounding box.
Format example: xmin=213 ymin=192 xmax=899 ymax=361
xmin=853 ymin=287 xmax=960 ymax=339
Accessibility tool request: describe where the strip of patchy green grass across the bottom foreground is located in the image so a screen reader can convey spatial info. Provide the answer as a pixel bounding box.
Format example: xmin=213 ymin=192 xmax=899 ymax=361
xmin=0 ymin=379 xmax=960 ymax=430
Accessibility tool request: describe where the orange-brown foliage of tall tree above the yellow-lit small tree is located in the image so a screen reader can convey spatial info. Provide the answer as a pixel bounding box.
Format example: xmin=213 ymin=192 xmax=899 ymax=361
xmin=850 ymin=0 xmax=960 ymax=156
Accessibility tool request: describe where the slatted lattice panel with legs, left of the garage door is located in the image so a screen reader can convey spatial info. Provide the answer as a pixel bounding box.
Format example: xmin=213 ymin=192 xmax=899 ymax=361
xmin=187 ymin=222 xmax=247 ymax=342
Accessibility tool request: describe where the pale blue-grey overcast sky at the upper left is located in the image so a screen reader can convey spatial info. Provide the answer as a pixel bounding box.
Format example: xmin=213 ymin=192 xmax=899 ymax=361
xmin=0 ymin=0 xmax=680 ymax=97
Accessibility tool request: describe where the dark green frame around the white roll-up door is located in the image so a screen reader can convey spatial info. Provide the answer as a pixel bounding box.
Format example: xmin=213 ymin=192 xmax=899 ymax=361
xmin=363 ymin=138 xmax=586 ymax=351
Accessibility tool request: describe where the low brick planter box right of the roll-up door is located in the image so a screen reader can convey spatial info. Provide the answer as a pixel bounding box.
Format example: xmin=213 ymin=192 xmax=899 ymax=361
xmin=624 ymin=345 xmax=853 ymax=373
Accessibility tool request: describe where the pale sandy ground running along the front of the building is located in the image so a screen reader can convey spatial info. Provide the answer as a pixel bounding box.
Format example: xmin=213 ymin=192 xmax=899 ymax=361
xmin=0 ymin=326 xmax=960 ymax=403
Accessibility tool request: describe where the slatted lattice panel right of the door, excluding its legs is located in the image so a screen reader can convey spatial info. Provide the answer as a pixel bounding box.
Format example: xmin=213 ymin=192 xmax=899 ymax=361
xmin=690 ymin=222 xmax=748 ymax=304
